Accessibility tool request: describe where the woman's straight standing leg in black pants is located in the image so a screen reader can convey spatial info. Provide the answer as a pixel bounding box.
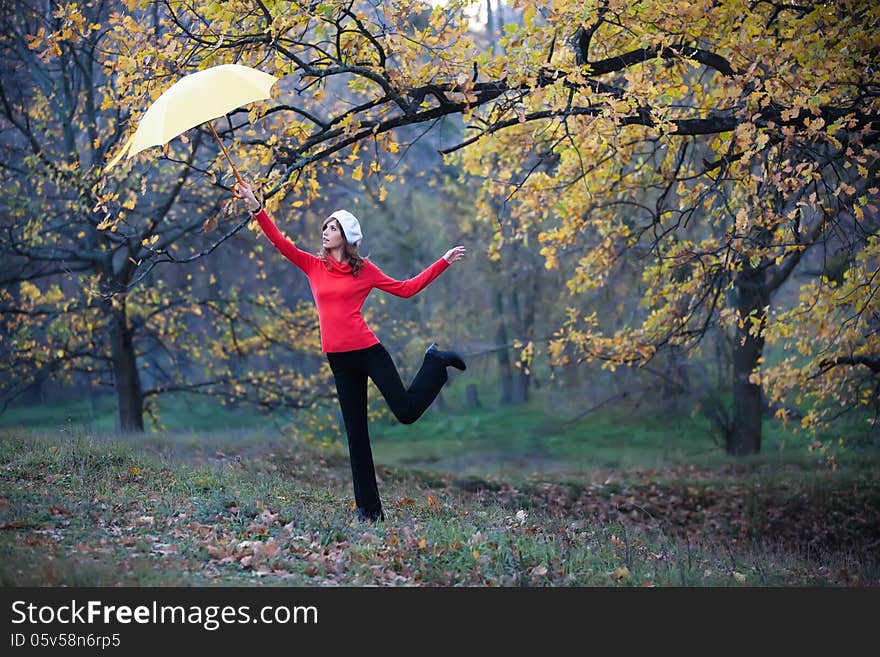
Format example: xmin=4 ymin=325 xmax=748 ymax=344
xmin=328 ymin=354 xmax=382 ymax=519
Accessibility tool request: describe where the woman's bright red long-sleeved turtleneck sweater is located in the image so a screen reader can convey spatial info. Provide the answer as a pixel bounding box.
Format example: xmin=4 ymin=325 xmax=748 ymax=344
xmin=254 ymin=208 xmax=449 ymax=352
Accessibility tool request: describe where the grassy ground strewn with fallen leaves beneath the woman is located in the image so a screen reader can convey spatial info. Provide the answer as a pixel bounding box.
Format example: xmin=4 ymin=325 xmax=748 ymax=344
xmin=0 ymin=400 xmax=880 ymax=586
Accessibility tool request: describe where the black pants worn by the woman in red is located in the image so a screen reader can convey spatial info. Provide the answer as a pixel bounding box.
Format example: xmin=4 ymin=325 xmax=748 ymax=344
xmin=327 ymin=344 xmax=448 ymax=520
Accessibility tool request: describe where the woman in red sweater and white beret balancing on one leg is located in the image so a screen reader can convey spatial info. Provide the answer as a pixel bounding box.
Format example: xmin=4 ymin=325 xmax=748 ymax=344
xmin=234 ymin=183 xmax=467 ymax=521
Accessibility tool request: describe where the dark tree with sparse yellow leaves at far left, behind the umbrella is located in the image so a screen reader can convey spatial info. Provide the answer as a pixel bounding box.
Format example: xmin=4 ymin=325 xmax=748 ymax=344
xmin=0 ymin=3 xmax=329 ymax=431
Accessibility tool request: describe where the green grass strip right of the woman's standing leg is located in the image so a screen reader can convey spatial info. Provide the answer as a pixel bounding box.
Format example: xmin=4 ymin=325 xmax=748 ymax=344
xmin=371 ymin=394 xmax=880 ymax=476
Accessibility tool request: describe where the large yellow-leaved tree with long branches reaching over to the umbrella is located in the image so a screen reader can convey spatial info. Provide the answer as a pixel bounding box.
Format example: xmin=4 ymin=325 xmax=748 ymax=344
xmin=5 ymin=0 xmax=880 ymax=454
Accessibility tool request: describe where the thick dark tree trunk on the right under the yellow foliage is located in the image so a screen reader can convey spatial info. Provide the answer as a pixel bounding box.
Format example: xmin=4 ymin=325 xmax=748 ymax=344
xmin=727 ymin=264 xmax=770 ymax=456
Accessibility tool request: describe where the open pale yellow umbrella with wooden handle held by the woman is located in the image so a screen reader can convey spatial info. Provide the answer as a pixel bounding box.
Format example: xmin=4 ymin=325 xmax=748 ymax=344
xmin=104 ymin=64 xmax=278 ymax=182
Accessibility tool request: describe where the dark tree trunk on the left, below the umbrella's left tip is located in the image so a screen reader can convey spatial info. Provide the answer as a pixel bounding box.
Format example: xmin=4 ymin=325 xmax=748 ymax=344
xmin=109 ymin=295 xmax=144 ymax=433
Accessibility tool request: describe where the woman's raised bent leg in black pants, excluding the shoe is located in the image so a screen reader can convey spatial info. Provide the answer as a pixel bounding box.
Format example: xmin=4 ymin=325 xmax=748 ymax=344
xmin=367 ymin=344 xmax=449 ymax=424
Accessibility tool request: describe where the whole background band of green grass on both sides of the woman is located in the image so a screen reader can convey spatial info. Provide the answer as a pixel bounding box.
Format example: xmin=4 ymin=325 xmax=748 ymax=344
xmin=0 ymin=385 xmax=880 ymax=477
